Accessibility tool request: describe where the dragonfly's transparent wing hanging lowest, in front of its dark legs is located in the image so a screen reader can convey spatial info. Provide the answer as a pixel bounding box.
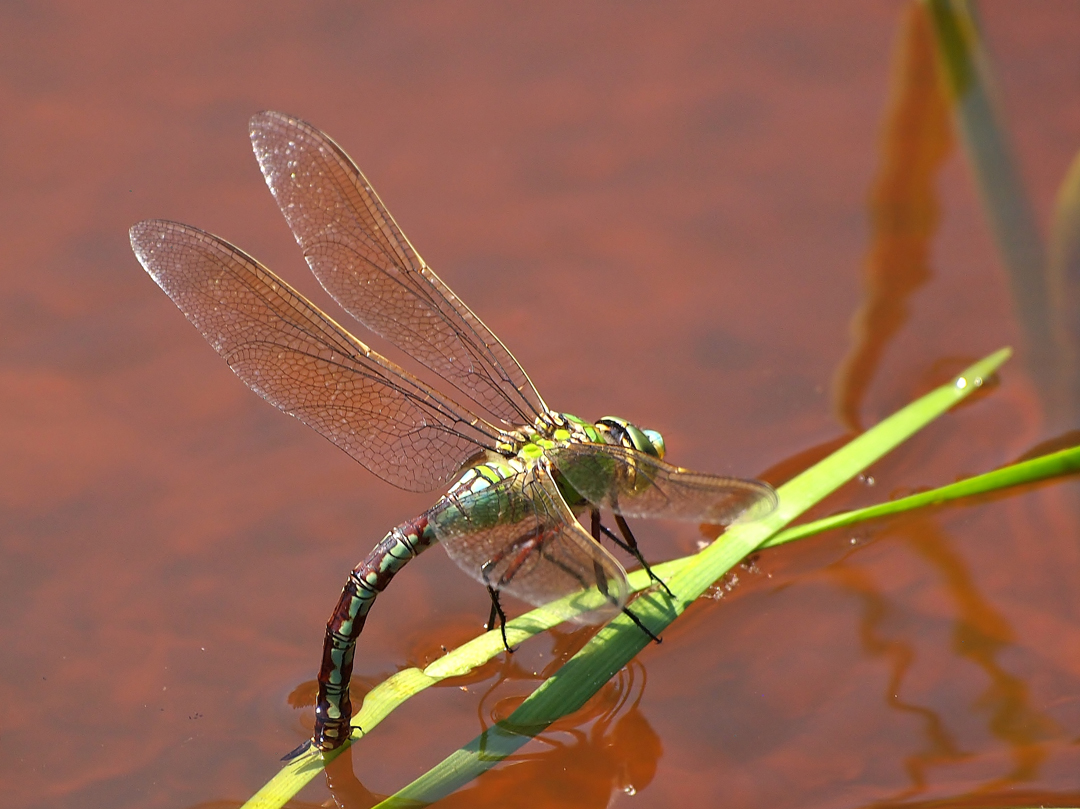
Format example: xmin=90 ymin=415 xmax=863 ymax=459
xmin=428 ymin=463 xmax=630 ymax=623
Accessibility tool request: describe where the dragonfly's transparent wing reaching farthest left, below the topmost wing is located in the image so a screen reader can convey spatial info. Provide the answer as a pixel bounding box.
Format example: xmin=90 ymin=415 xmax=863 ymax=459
xmin=131 ymin=219 xmax=498 ymax=491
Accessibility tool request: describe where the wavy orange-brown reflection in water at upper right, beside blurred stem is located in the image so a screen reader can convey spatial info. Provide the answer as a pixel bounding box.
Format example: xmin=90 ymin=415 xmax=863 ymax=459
xmin=833 ymin=3 xmax=953 ymax=431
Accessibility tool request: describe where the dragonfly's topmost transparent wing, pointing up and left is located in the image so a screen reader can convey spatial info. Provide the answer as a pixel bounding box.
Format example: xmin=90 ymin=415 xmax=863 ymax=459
xmin=251 ymin=112 xmax=546 ymax=436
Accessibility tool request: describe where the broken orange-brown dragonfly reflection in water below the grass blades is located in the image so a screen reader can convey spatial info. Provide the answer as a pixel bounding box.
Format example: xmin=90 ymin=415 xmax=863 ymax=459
xmin=315 ymin=661 xmax=663 ymax=809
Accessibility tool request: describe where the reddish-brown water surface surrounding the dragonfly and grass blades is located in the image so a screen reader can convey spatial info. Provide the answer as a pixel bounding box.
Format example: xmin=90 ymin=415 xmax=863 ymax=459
xmin=0 ymin=0 xmax=1080 ymax=808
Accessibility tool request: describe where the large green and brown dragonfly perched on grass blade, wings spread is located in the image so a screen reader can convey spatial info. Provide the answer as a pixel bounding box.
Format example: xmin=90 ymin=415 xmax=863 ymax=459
xmin=130 ymin=111 xmax=777 ymax=752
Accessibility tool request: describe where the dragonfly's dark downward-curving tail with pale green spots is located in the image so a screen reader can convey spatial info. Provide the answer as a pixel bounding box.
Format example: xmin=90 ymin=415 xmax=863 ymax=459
xmin=301 ymin=516 xmax=437 ymax=751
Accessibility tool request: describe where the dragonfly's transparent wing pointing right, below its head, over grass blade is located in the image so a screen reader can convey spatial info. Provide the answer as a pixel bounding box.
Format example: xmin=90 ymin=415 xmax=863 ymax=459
xmin=546 ymin=444 xmax=778 ymax=525
